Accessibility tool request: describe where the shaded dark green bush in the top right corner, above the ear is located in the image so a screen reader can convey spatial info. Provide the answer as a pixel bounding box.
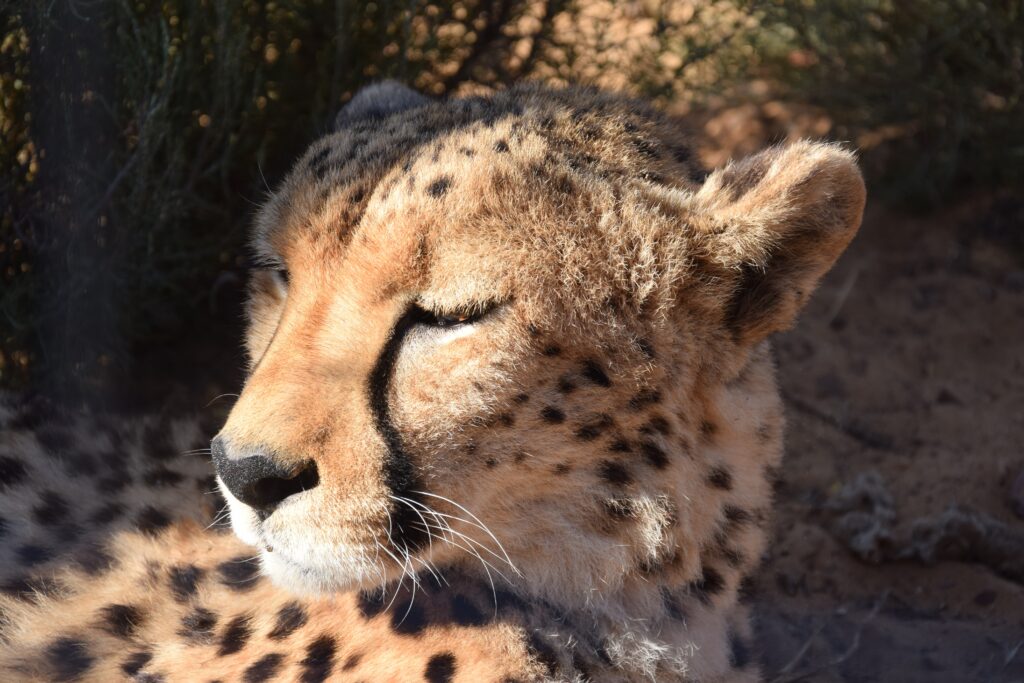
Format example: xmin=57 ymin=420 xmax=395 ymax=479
xmin=758 ymin=0 xmax=1024 ymax=206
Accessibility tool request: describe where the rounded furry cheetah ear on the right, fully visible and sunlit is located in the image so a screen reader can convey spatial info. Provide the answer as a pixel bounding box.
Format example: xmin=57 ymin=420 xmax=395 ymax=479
xmin=693 ymin=141 xmax=865 ymax=344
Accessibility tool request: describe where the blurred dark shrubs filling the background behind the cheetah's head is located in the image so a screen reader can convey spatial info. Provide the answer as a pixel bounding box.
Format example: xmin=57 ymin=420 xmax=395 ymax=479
xmin=0 ymin=0 xmax=1024 ymax=392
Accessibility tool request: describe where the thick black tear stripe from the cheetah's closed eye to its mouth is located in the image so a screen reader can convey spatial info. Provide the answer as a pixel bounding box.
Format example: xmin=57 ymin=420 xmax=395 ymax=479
xmin=367 ymin=307 xmax=427 ymax=550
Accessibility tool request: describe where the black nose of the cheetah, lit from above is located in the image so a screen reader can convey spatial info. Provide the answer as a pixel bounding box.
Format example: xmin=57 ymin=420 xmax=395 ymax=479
xmin=211 ymin=436 xmax=319 ymax=519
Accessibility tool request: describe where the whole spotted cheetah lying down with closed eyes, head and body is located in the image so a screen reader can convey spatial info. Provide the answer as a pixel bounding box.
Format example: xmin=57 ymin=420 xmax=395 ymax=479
xmin=0 ymin=82 xmax=865 ymax=683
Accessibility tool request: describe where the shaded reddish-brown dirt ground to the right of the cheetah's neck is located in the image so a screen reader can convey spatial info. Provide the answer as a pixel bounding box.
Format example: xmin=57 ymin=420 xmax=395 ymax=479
xmin=753 ymin=194 xmax=1024 ymax=683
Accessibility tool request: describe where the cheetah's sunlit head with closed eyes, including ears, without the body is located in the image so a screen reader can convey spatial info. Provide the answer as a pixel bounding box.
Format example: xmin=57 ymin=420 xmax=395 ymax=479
xmin=213 ymin=85 xmax=863 ymax=594
